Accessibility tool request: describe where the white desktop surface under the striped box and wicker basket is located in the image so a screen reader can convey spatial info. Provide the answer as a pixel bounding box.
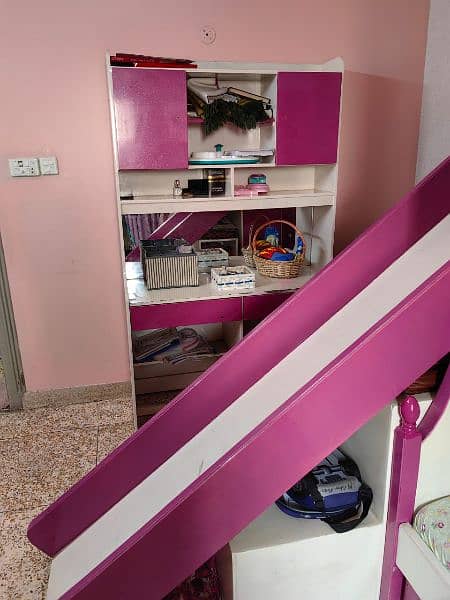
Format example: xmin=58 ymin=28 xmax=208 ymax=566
xmin=125 ymin=256 xmax=317 ymax=306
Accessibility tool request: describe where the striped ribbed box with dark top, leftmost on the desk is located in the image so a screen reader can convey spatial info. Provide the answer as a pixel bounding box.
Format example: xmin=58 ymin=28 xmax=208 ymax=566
xmin=141 ymin=239 xmax=199 ymax=290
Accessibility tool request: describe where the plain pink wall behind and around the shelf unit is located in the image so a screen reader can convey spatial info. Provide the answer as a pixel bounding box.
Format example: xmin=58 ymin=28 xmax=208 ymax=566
xmin=0 ymin=0 xmax=429 ymax=390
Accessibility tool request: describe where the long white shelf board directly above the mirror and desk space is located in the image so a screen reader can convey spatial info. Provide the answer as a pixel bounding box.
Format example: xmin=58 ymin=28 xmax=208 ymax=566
xmin=120 ymin=189 xmax=335 ymax=215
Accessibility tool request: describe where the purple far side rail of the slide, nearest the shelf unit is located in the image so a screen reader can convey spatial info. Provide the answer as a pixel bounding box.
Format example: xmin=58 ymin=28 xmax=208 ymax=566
xmin=29 ymin=158 xmax=450 ymax=556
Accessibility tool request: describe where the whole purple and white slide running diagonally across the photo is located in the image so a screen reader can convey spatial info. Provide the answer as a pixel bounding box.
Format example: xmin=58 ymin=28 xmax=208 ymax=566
xmin=29 ymin=159 xmax=450 ymax=600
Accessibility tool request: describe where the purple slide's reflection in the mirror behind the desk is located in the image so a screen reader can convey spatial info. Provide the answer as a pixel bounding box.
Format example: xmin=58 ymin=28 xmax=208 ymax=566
xmin=126 ymin=211 xmax=226 ymax=261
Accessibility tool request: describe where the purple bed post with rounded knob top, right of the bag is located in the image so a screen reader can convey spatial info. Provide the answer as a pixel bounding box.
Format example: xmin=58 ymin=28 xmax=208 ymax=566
xmin=380 ymin=396 xmax=422 ymax=600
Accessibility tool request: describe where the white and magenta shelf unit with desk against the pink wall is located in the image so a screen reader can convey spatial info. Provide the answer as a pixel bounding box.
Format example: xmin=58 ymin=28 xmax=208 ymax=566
xmin=108 ymin=59 xmax=343 ymax=404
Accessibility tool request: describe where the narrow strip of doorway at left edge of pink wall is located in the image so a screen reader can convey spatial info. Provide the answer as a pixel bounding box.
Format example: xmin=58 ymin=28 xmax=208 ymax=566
xmin=0 ymin=236 xmax=25 ymax=410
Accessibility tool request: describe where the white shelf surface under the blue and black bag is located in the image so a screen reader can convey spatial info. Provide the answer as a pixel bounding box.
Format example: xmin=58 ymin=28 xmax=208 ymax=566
xmin=230 ymin=504 xmax=382 ymax=553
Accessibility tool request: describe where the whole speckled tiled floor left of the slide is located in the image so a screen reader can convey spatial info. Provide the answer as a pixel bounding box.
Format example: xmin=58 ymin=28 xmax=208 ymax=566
xmin=0 ymin=398 xmax=134 ymax=600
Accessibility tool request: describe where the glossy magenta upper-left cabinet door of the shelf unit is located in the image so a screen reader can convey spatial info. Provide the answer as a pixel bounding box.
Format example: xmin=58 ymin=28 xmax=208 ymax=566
xmin=112 ymin=67 xmax=188 ymax=169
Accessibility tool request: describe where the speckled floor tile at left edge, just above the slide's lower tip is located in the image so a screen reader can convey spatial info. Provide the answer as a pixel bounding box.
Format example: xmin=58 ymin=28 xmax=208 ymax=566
xmin=0 ymin=427 xmax=98 ymax=511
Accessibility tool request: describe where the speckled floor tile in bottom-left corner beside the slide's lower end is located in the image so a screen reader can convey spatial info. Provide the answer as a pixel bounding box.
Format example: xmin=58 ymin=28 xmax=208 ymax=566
xmin=0 ymin=507 xmax=50 ymax=600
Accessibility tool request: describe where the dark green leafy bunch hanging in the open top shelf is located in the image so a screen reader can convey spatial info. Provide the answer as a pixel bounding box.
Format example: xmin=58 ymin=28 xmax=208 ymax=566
xmin=202 ymin=98 xmax=267 ymax=135
